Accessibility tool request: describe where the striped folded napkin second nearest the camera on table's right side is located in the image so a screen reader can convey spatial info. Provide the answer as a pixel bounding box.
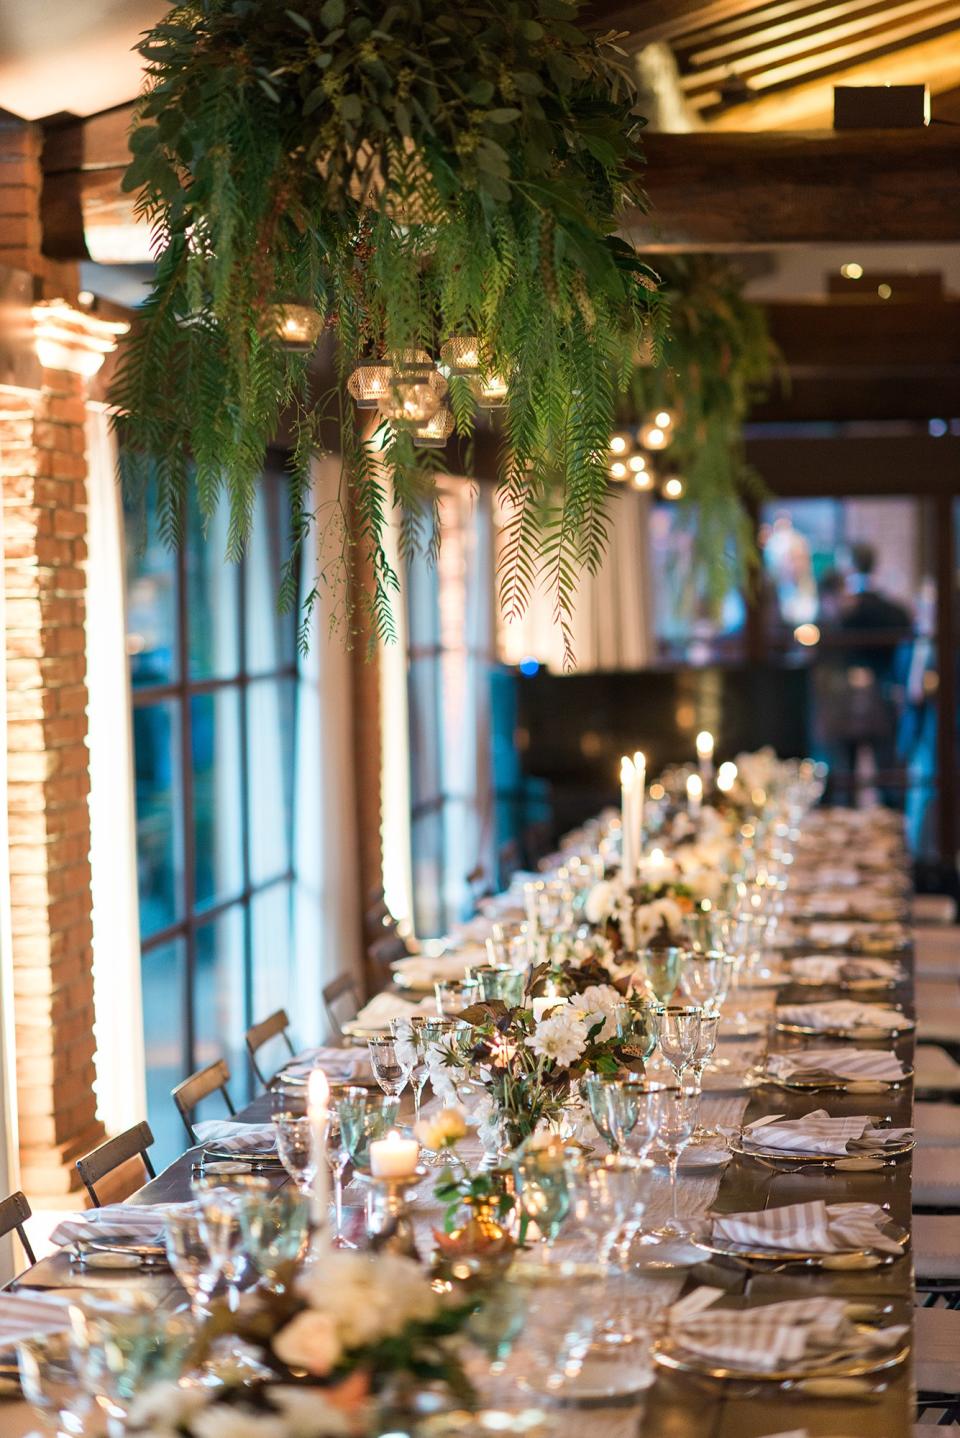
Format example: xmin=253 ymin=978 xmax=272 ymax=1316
xmin=710 ymin=1199 xmax=903 ymax=1257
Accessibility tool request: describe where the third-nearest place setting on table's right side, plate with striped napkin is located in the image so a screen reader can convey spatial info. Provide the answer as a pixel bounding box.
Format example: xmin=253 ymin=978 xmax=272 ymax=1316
xmin=731 ymin=1109 xmax=914 ymax=1172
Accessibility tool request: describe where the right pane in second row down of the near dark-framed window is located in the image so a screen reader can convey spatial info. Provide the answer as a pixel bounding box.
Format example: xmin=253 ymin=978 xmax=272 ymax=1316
xmin=247 ymin=679 xmax=296 ymax=884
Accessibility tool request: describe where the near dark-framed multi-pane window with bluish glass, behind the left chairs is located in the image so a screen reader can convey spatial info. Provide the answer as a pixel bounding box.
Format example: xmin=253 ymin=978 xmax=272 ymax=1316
xmin=126 ymin=464 xmax=297 ymax=1160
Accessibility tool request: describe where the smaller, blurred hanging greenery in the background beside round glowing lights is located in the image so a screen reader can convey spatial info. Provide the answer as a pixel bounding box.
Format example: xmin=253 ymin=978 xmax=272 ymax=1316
xmin=629 ymin=255 xmax=779 ymax=598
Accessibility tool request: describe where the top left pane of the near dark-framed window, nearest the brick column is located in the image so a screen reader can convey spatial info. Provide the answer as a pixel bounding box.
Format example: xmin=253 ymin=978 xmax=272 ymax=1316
xmin=126 ymin=508 xmax=177 ymax=689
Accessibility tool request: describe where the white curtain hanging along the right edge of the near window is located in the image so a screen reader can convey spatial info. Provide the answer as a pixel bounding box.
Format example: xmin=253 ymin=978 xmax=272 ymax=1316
xmin=293 ymin=457 xmax=361 ymax=1041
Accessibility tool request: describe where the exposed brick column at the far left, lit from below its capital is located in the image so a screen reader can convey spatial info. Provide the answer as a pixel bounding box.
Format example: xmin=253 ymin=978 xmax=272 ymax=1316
xmin=0 ymin=370 xmax=102 ymax=1205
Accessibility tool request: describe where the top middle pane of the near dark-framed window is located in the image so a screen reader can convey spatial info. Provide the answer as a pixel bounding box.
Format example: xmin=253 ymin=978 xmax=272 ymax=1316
xmin=185 ymin=489 xmax=240 ymax=679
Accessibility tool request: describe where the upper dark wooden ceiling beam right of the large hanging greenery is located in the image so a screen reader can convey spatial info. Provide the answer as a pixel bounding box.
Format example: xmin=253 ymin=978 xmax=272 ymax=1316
xmin=624 ymin=129 xmax=960 ymax=252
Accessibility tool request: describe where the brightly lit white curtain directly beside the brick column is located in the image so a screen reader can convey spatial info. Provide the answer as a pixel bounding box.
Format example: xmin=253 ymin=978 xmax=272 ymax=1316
xmin=86 ymin=404 xmax=147 ymax=1133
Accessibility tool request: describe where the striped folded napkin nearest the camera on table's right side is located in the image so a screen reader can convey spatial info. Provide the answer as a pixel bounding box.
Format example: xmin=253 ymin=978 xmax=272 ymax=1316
xmin=671 ymin=1294 xmax=907 ymax=1372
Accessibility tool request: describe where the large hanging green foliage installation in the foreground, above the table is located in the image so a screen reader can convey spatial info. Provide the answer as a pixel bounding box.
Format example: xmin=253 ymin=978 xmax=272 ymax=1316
xmin=112 ymin=0 xmax=658 ymax=652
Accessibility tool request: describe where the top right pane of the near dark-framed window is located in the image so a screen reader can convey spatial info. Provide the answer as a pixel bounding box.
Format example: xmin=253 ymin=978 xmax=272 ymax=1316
xmin=244 ymin=473 xmax=297 ymax=674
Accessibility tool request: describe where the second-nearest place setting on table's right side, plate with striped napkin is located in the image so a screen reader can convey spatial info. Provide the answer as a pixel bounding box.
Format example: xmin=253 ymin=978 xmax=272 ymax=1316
xmin=693 ymin=1199 xmax=908 ymax=1268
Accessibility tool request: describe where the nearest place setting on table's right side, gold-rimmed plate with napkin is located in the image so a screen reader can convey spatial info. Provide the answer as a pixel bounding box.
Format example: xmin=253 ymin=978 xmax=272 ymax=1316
xmin=654 ymin=1288 xmax=910 ymax=1383
